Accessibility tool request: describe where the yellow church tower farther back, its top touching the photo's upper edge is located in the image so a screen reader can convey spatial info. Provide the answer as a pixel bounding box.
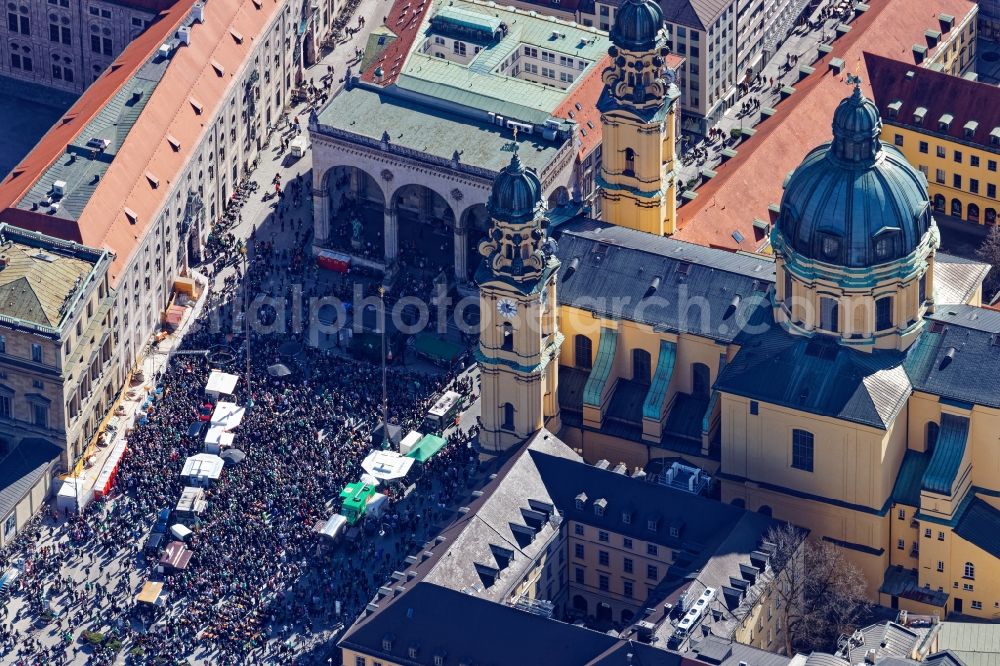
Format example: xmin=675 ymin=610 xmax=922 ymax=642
xmin=598 ymin=0 xmax=679 ymax=236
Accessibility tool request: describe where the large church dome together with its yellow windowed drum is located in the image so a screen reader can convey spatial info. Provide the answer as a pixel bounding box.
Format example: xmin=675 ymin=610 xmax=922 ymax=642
xmin=771 ymin=77 xmax=940 ymax=351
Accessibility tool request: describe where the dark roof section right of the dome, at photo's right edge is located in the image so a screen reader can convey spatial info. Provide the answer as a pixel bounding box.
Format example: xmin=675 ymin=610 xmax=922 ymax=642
xmin=906 ymin=305 xmax=1000 ymax=408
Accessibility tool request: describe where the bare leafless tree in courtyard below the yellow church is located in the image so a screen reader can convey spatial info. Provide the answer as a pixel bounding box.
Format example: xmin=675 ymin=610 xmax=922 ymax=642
xmin=767 ymin=523 xmax=871 ymax=655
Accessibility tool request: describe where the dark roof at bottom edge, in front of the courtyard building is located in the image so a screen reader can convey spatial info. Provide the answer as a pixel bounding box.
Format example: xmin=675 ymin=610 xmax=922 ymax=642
xmin=340 ymin=582 xmax=624 ymax=666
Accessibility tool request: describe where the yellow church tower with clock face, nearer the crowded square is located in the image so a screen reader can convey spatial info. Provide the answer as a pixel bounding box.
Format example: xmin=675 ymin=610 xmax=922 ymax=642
xmin=476 ymin=142 xmax=562 ymax=451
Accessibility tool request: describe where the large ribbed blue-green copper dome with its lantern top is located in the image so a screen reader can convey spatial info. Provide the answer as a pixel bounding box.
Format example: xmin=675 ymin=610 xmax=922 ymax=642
xmin=775 ymin=86 xmax=933 ymax=268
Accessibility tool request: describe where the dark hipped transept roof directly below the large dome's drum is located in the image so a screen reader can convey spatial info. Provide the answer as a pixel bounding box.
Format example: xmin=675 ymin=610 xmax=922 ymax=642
xmin=715 ymin=329 xmax=910 ymax=429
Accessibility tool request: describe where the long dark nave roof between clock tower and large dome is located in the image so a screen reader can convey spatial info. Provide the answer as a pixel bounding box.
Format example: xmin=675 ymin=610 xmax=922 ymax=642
xmin=558 ymin=220 xmax=774 ymax=343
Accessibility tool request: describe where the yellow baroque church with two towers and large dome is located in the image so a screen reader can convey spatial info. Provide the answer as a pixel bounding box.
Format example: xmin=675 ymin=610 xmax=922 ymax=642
xmin=476 ymin=0 xmax=1000 ymax=618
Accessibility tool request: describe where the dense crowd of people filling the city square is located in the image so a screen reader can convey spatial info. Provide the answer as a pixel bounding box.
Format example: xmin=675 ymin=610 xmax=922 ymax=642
xmin=0 ymin=158 xmax=479 ymax=666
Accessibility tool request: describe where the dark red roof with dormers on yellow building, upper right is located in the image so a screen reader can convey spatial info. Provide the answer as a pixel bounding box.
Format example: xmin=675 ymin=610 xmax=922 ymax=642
xmin=865 ymin=53 xmax=1000 ymax=147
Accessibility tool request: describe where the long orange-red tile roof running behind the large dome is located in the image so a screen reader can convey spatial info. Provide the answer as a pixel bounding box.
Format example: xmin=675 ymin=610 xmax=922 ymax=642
xmin=675 ymin=0 xmax=976 ymax=251
